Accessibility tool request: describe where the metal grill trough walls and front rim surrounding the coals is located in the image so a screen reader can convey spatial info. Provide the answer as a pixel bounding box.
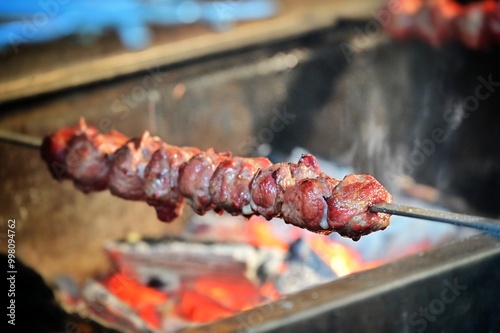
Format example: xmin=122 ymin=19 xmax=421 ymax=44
xmin=0 ymin=22 xmax=500 ymax=332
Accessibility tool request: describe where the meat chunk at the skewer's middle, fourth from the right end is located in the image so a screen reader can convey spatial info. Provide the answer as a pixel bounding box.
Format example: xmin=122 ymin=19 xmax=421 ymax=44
xmin=209 ymin=157 xmax=272 ymax=215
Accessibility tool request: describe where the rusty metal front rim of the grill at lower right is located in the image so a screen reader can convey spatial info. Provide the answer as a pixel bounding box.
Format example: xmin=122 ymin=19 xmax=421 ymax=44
xmin=182 ymin=235 xmax=500 ymax=333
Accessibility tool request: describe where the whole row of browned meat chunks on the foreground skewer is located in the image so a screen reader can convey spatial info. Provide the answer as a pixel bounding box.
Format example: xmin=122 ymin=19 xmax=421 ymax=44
xmin=41 ymin=120 xmax=392 ymax=240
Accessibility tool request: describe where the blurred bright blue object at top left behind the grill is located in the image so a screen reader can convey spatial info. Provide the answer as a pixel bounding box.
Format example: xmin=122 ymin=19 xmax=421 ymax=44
xmin=0 ymin=0 xmax=278 ymax=51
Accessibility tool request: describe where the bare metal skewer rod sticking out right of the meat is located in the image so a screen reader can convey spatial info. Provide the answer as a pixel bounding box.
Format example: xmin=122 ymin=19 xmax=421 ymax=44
xmin=370 ymin=203 xmax=500 ymax=236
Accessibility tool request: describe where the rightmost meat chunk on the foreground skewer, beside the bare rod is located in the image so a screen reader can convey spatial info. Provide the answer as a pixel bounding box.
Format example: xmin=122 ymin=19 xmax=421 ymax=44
xmin=327 ymin=175 xmax=393 ymax=240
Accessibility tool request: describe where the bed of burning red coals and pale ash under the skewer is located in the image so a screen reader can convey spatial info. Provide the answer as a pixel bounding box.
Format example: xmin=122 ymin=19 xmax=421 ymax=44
xmin=59 ymin=149 xmax=473 ymax=332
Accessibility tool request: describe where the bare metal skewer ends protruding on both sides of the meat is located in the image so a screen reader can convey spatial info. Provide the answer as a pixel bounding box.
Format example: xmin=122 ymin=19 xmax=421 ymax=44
xmin=0 ymin=129 xmax=500 ymax=236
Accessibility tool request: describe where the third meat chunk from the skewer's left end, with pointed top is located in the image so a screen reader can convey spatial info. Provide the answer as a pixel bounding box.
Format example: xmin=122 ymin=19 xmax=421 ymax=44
xmin=109 ymin=132 xmax=162 ymax=200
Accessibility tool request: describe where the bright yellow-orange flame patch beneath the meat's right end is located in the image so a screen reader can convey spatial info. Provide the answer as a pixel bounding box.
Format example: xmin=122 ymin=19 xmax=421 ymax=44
xmin=308 ymin=236 xmax=381 ymax=277
